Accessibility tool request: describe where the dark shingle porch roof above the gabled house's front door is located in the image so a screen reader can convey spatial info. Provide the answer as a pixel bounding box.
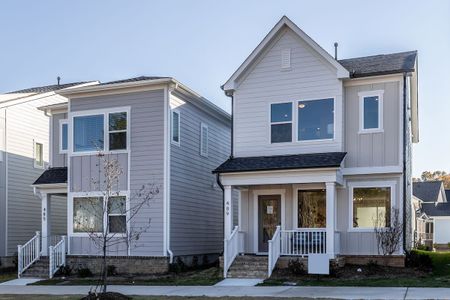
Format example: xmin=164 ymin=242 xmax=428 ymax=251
xmin=213 ymin=152 xmax=347 ymax=173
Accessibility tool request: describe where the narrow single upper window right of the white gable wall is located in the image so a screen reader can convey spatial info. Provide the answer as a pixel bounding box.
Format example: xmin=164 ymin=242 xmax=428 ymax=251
xmin=358 ymin=91 xmax=383 ymax=132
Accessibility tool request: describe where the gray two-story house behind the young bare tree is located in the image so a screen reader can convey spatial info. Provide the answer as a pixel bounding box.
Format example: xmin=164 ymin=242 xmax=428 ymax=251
xmin=23 ymin=77 xmax=231 ymax=272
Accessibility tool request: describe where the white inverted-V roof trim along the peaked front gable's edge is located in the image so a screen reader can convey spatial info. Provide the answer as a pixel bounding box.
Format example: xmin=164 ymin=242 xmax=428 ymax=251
xmin=222 ymin=16 xmax=349 ymax=91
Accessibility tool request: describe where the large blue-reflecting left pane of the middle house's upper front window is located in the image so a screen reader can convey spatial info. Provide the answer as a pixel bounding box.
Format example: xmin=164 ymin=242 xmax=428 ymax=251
xmin=73 ymin=114 xmax=104 ymax=152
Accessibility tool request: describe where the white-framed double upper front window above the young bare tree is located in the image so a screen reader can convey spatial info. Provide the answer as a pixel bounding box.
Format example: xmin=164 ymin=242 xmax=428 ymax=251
xmin=72 ymin=109 xmax=129 ymax=153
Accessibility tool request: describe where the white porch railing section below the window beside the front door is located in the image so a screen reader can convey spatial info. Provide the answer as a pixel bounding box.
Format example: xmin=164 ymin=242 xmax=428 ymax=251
xmin=281 ymin=228 xmax=327 ymax=256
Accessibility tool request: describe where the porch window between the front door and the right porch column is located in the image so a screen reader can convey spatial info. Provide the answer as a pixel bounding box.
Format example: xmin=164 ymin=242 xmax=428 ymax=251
xmin=297 ymin=190 xmax=327 ymax=228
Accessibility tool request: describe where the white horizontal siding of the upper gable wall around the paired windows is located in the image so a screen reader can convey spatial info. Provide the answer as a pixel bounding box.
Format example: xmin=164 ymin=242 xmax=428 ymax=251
xmin=234 ymin=29 xmax=343 ymax=157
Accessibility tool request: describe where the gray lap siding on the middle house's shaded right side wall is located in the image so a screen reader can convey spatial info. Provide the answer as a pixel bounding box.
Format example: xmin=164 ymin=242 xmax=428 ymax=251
xmin=170 ymin=93 xmax=230 ymax=255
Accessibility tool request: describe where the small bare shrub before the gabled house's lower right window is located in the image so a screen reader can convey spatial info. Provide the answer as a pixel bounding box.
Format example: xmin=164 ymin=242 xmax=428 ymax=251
xmin=374 ymin=208 xmax=403 ymax=256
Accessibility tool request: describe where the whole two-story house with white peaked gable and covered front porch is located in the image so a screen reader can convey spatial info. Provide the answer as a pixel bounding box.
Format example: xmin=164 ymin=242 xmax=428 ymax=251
xmin=215 ymin=17 xmax=419 ymax=277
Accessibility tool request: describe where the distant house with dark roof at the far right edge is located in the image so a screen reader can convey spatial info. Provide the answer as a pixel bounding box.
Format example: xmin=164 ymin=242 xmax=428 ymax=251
xmin=413 ymin=181 xmax=450 ymax=250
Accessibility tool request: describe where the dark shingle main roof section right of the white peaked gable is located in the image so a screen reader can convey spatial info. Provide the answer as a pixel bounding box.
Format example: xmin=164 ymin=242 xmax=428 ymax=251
xmin=339 ymin=51 xmax=417 ymax=78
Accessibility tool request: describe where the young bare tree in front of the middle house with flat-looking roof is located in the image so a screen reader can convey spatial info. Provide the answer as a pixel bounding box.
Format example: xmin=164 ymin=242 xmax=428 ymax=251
xmin=74 ymin=151 xmax=159 ymax=293
